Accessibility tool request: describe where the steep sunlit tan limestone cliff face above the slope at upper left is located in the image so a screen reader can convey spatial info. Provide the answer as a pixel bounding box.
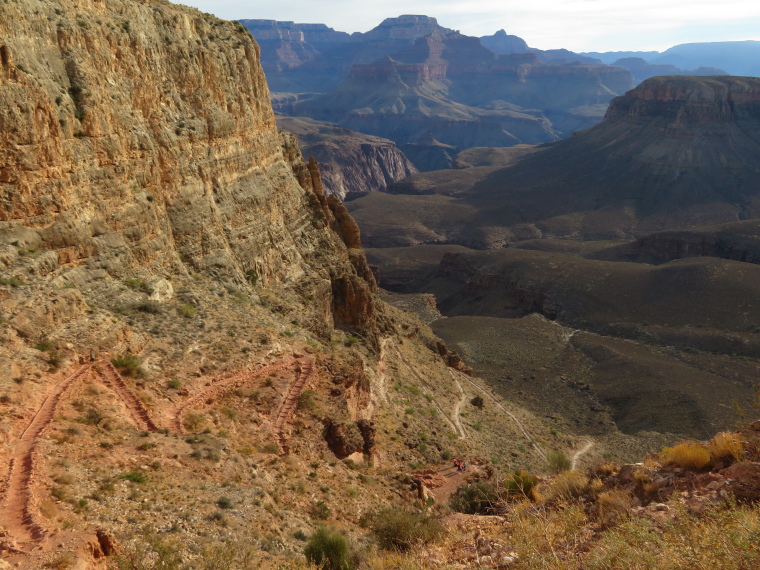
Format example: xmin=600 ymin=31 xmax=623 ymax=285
xmin=0 ymin=0 xmax=373 ymax=327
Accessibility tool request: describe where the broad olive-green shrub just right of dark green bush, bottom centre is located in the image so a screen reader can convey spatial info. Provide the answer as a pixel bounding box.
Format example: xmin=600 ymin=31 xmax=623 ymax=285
xmin=365 ymin=508 xmax=445 ymax=551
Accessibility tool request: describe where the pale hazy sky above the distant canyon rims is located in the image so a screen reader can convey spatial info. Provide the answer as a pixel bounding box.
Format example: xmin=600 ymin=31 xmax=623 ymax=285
xmin=181 ymin=0 xmax=760 ymax=52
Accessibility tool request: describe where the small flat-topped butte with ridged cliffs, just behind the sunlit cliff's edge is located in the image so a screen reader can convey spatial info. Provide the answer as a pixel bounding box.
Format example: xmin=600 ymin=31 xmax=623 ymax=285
xmin=277 ymin=117 xmax=417 ymax=199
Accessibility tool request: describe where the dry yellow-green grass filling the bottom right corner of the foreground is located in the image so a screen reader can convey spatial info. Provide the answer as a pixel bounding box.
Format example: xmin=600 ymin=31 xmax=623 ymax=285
xmin=498 ymin=490 xmax=760 ymax=570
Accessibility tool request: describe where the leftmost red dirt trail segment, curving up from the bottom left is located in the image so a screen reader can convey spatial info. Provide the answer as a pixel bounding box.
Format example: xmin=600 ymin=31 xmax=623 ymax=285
xmin=0 ymin=364 xmax=92 ymax=548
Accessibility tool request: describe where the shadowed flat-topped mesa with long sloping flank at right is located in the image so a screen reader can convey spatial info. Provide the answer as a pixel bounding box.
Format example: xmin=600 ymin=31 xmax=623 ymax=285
xmin=351 ymin=76 xmax=760 ymax=248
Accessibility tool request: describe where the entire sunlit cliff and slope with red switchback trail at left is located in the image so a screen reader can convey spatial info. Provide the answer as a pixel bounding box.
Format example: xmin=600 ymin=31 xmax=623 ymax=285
xmin=0 ymin=0 xmax=588 ymax=568
